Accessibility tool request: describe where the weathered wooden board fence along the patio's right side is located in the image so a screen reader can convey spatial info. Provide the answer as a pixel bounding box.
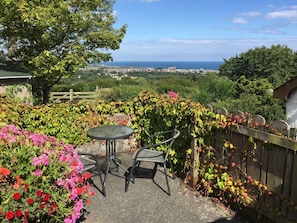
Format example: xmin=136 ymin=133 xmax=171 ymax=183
xmin=192 ymin=109 xmax=297 ymax=223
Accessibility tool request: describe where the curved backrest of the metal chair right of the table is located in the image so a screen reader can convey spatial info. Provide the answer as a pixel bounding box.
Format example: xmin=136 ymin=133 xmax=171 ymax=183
xmin=144 ymin=129 xmax=180 ymax=158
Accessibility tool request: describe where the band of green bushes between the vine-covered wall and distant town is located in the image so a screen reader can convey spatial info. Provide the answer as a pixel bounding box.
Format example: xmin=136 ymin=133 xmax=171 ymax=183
xmin=51 ymin=68 xmax=285 ymax=121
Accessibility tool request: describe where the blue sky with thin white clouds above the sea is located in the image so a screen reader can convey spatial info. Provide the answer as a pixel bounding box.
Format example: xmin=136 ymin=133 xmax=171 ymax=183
xmin=112 ymin=0 xmax=297 ymax=61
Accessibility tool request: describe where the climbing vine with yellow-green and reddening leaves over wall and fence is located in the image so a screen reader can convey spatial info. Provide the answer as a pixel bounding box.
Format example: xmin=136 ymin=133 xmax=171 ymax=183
xmin=0 ymin=90 xmax=292 ymax=213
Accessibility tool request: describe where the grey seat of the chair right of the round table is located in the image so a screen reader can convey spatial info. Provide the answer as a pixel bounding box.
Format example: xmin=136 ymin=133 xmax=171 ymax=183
xmin=133 ymin=149 xmax=164 ymax=163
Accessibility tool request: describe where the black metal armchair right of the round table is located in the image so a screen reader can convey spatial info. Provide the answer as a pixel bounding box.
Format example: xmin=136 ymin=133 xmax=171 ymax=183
xmin=125 ymin=130 xmax=180 ymax=195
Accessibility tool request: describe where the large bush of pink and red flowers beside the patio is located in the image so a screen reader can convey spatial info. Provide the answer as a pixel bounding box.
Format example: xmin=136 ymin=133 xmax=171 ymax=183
xmin=0 ymin=125 xmax=92 ymax=223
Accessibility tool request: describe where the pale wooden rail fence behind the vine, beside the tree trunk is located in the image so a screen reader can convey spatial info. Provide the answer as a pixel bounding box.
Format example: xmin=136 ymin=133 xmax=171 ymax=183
xmin=50 ymin=86 xmax=111 ymax=103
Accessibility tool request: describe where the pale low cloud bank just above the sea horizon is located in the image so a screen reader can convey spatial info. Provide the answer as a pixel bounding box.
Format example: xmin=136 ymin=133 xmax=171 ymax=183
xmin=112 ymin=38 xmax=297 ymax=61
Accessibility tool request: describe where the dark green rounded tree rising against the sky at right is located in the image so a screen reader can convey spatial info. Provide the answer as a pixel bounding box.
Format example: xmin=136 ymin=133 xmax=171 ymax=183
xmin=219 ymin=45 xmax=297 ymax=88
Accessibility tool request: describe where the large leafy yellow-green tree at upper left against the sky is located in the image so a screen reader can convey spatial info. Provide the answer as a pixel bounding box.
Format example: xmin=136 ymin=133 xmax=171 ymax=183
xmin=0 ymin=0 xmax=126 ymax=103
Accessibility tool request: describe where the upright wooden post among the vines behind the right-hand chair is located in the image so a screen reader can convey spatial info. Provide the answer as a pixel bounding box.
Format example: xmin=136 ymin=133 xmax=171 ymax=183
xmin=190 ymin=123 xmax=199 ymax=188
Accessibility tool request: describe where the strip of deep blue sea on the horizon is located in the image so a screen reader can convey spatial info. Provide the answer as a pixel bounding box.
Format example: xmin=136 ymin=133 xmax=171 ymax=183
xmin=100 ymin=61 xmax=223 ymax=70
